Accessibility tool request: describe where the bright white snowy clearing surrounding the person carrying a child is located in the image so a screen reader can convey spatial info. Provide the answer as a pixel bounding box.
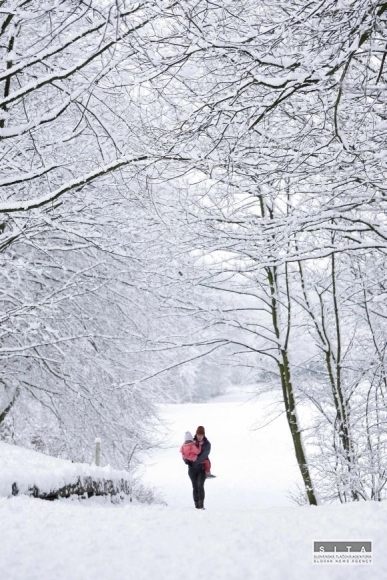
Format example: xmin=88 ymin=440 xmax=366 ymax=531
xmin=144 ymin=390 xmax=301 ymax=509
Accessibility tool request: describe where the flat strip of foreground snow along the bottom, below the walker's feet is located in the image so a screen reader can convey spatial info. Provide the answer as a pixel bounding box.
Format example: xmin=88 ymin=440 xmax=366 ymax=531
xmin=0 ymin=497 xmax=387 ymax=580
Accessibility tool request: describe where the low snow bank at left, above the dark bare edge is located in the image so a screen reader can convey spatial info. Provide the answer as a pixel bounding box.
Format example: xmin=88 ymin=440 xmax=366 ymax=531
xmin=0 ymin=442 xmax=130 ymax=497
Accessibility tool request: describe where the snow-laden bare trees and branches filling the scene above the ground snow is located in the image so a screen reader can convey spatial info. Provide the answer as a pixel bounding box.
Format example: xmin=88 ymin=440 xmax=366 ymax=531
xmin=0 ymin=0 xmax=387 ymax=504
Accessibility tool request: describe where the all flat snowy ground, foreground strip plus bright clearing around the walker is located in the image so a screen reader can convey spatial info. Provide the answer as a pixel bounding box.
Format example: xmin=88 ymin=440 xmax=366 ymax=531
xmin=0 ymin=386 xmax=387 ymax=580
